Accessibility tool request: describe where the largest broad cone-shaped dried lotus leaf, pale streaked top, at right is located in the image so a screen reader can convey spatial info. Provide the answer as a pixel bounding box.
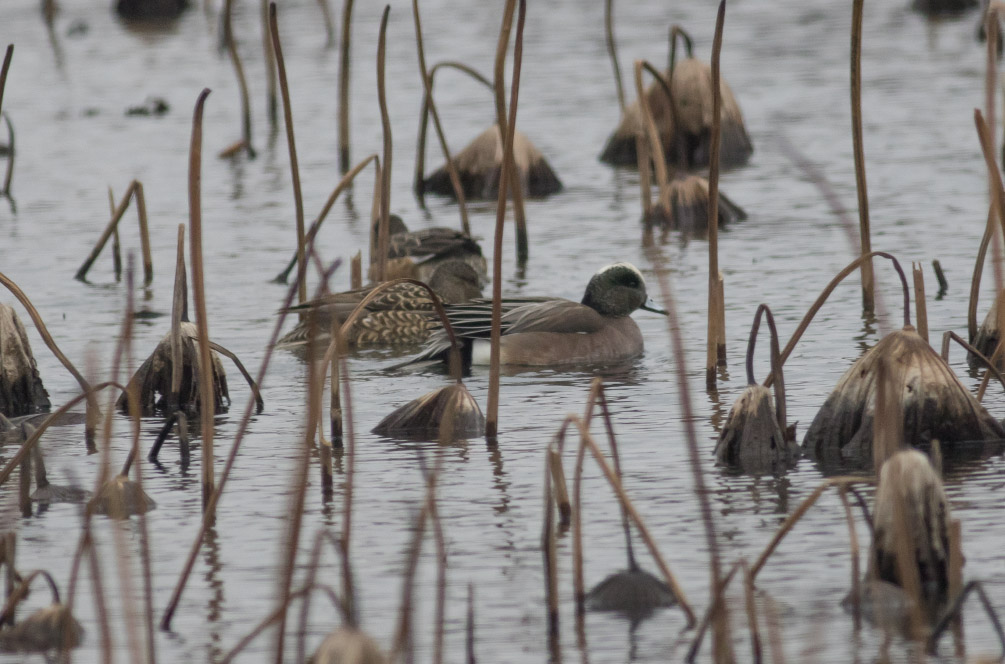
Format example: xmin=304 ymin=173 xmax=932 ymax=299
xmin=803 ymin=325 xmax=1005 ymax=463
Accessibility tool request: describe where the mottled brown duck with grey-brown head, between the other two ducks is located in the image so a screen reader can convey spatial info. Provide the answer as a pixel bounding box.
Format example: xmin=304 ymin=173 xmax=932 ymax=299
xmin=278 ymin=260 xmax=481 ymax=347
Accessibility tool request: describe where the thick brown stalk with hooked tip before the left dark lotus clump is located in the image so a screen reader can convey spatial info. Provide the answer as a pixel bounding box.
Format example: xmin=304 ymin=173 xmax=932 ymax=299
xmin=189 ymin=87 xmax=216 ymax=512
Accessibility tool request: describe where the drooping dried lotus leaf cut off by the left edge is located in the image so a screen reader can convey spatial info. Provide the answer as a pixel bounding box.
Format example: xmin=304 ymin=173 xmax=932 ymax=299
xmin=0 ymin=303 xmax=51 ymax=418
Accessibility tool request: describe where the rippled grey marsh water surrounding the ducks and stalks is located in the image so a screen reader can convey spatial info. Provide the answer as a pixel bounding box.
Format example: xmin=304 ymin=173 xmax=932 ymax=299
xmin=0 ymin=0 xmax=1005 ymax=662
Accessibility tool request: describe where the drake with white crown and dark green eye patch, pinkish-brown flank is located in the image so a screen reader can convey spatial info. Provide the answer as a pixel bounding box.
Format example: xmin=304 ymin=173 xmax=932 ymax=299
xmin=399 ymin=263 xmax=666 ymax=367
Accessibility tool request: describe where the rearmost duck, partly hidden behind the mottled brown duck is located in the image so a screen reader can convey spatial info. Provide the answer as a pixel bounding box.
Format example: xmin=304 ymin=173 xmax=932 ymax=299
xmin=369 ymin=214 xmax=487 ymax=283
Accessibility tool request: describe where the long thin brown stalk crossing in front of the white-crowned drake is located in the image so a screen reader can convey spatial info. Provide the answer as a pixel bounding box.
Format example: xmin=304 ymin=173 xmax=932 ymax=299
xmin=485 ymin=0 xmax=527 ymax=440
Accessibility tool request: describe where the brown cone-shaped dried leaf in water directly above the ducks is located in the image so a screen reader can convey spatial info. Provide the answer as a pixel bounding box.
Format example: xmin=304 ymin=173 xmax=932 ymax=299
xmin=423 ymin=125 xmax=562 ymax=200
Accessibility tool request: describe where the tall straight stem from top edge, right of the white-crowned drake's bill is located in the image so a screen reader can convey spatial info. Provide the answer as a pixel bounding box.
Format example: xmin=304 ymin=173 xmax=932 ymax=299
xmin=705 ymin=0 xmax=726 ymax=390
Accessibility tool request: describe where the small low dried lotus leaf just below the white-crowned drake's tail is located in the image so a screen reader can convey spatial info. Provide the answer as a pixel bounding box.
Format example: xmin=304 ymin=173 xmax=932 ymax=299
xmin=373 ymin=382 xmax=485 ymax=442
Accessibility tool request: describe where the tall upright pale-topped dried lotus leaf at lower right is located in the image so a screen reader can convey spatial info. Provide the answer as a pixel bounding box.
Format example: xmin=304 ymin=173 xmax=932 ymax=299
xmin=871 ymin=450 xmax=950 ymax=608
